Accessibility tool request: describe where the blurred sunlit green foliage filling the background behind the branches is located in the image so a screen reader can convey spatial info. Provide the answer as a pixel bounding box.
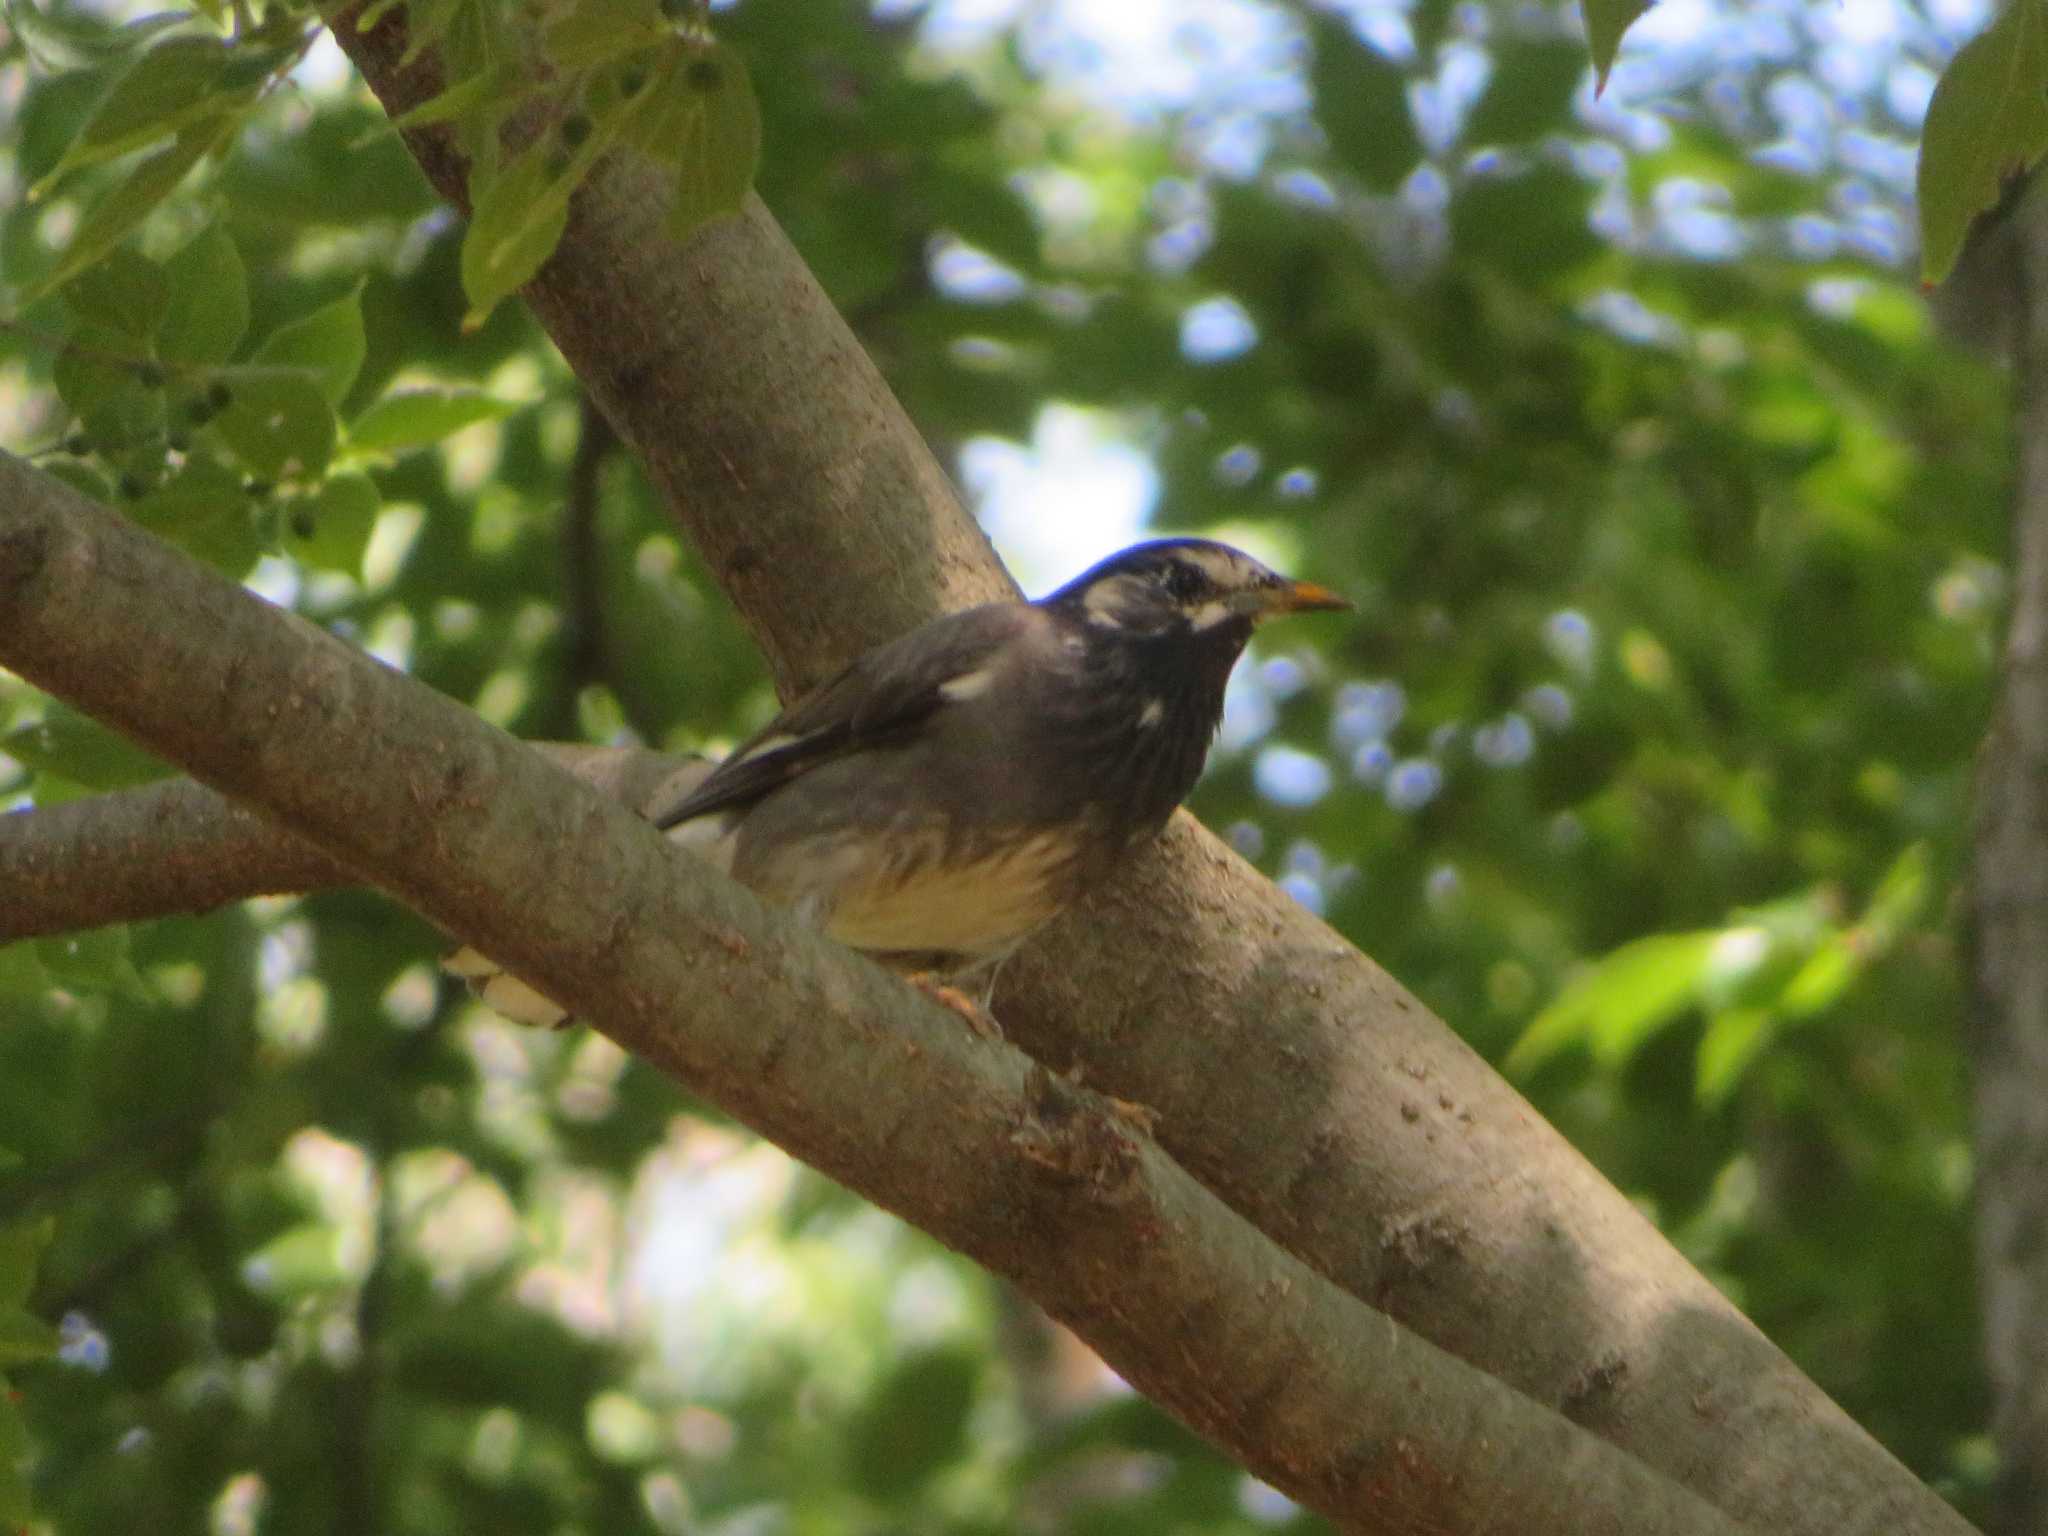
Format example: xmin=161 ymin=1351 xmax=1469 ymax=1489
xmin=0 ymin=0 xmax=2009 ymax=1532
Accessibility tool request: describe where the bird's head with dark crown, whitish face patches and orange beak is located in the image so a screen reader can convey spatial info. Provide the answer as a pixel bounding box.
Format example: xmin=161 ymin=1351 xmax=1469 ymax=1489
xmin=1044 ymin=539 xmax=1352 ymax=651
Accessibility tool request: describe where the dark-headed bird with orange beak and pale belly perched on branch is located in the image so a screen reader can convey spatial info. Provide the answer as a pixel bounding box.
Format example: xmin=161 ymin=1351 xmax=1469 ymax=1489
xmin=446 ymin=539 xmax=1352 ymax=1032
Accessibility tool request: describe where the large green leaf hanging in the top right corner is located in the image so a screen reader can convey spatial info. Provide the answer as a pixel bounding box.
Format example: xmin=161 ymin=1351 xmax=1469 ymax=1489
xmin=1917 ymin=0 xmax=2048 ymax=283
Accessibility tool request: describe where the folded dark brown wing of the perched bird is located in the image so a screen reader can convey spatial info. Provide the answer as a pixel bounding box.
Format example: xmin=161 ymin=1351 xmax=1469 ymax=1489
xmin=653 ymin=602 xmax=1047 ymax=829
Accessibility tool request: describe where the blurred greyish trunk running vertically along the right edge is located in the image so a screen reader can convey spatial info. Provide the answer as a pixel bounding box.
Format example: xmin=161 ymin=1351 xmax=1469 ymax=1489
xmin=1970 ymin=190 xmax=2048 ymax=1536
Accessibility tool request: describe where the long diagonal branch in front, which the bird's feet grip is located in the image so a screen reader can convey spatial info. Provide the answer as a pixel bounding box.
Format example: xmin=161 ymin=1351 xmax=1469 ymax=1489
xmin=0 ymin=455 xmax=1761 ymax=1536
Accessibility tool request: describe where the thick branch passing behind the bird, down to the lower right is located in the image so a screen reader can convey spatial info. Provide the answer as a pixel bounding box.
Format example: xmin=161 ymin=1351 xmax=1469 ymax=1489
xmin=307 ymin=10 xmax=1966 ymax=1536
